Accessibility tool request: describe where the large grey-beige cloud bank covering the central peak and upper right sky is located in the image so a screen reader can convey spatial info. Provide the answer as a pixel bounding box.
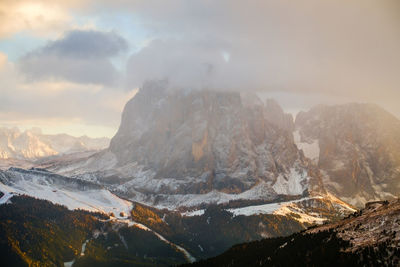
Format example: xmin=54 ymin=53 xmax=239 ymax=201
xmin=121 ymin=0 xmax=400 ymax=114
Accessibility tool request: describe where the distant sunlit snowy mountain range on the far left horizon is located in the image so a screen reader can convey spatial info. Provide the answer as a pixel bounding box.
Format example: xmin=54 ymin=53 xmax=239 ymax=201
xmin=0 ymin=128 xmax=109 ymax=160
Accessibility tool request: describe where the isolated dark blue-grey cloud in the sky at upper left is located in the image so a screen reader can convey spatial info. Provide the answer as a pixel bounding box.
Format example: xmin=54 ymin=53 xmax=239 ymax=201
xmin=18 ymin=30 xmax=128 ymax=85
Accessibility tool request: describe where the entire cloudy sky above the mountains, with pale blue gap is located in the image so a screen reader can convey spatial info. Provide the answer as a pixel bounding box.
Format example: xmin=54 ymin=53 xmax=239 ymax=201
xmin=0 ymin=0 xmax=400 ymax=137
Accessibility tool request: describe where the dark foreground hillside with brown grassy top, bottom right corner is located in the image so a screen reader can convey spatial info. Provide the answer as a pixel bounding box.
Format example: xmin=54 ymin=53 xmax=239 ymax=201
xmin=188 ymin=199 xmax=400 ymax=266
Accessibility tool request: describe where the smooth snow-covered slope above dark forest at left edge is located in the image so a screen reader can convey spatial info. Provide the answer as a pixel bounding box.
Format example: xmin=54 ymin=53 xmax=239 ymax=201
xmin=0 ymin=168 xmax=132 ymax=217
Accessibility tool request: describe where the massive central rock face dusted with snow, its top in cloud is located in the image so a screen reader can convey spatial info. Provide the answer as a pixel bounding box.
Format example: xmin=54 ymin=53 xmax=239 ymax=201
xmin=109 ymin=82 xmax=313 ymax=203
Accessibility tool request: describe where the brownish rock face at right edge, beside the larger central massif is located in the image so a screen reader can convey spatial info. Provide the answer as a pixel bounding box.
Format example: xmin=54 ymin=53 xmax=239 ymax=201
xmin=295 ymin=104 xmax=400 ymax=207
